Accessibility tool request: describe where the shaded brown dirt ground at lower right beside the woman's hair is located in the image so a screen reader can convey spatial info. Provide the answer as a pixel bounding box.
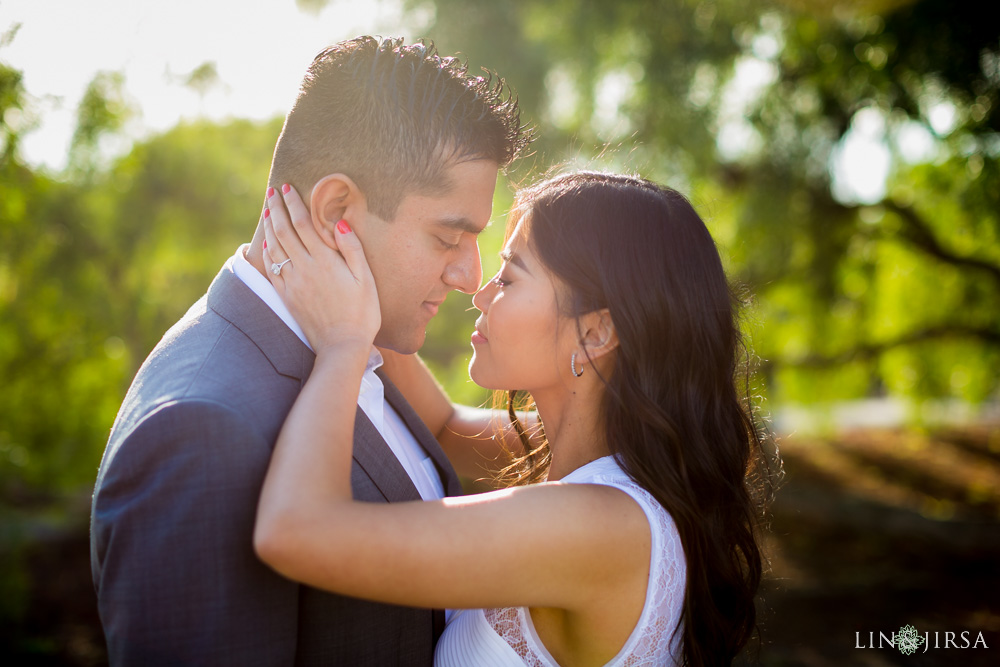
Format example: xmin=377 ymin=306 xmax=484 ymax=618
xmin=759 ymin=428 xmax=1000 ymax=667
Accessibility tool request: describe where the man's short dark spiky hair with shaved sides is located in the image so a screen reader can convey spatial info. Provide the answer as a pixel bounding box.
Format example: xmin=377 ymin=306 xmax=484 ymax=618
xmin=269 ymin=36 xmax=530 ymax=220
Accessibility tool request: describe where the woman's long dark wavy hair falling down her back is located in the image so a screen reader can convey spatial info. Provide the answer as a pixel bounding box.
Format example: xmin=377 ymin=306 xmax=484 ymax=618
xmin=496 ymin=172 xmax=780 ymax=667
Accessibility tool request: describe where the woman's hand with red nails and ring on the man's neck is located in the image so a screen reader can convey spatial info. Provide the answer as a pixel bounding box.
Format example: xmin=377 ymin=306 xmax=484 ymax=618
xmin=264 ymin=185 xmax=382 ymax=354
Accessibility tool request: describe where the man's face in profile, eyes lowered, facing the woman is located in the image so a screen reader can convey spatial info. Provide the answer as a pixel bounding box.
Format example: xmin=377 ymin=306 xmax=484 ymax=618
xmin=357 ymin=160 xmax=498 ymax=354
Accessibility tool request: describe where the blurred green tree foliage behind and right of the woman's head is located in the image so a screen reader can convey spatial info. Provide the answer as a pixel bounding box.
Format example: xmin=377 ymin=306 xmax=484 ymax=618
xmin=398 ymin=0 xmax=1000 ymax=408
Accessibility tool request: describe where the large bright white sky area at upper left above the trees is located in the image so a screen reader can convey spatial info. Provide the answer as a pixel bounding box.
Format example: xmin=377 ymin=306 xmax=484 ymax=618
xmin=0 ymin=0 xmax=419 ymax=169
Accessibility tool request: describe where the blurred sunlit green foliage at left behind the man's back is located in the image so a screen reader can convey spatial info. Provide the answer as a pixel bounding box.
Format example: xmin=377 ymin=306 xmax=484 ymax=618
xmin=0 ymin=58 xmax=280 ymax=495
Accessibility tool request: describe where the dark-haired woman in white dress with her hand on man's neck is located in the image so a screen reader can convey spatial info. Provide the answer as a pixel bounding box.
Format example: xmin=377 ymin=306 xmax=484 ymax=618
xmin=255 ymin=173 xmax=767 ymax=665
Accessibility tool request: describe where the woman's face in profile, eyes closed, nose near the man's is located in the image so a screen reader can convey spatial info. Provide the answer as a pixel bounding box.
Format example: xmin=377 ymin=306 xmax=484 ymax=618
xmin=469 ymin=218 xmax=576 ymax=394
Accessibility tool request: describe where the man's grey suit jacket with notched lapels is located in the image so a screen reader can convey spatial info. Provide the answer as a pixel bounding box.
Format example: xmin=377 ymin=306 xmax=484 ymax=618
xmin=90 ymin=268 xmax=461 ymax=666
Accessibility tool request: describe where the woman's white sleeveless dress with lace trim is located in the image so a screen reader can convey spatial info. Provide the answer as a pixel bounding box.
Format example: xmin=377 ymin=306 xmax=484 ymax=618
xmin=434 ymin=456 xmax=687 ymax=667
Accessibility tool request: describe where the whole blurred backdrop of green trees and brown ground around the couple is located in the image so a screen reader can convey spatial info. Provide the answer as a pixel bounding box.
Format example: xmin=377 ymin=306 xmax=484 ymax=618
xmin=0 ymin=0 xmax=1000 ymax=665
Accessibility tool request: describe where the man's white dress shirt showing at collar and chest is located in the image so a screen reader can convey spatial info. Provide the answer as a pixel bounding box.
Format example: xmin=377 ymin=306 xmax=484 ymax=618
xmin=226 ymin=244 xmax=445 ymax=500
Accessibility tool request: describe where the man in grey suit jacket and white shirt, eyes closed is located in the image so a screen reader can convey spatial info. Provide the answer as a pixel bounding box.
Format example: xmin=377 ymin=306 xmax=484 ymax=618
xmin=91 ymin=37 xmax=527 ymax=666
